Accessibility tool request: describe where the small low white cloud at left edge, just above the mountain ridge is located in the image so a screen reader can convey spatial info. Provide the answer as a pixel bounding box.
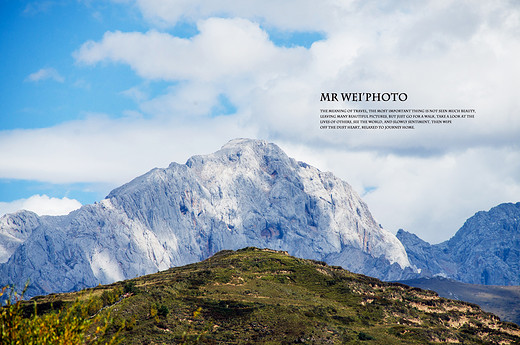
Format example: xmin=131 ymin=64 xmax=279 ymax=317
xmin=0 ymin=194 xmax=81 ymax=216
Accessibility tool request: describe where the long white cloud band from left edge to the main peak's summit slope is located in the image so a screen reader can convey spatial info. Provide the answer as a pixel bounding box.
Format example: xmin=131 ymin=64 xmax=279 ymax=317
xmin=0 ymin=113 xmax=252 ymax=185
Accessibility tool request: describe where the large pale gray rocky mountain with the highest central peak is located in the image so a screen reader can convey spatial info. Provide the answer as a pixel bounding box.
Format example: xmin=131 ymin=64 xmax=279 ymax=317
xmin=0 ymin=139 xmax=414 ymax=295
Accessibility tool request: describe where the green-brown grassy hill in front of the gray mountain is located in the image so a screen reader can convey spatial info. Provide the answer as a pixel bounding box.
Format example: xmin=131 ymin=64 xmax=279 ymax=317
xmin=18 ymin=248 xmax=520 ymax=345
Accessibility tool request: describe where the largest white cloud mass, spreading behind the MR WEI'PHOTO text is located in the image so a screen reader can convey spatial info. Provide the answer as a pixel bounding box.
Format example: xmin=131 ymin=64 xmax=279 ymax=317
xmin=75 ymin=6 xmax=520 ymax=155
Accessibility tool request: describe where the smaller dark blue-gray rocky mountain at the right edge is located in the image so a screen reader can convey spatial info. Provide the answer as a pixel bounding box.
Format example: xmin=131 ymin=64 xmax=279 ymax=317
xmin=397 ymin=203 xmax=520 ymax=285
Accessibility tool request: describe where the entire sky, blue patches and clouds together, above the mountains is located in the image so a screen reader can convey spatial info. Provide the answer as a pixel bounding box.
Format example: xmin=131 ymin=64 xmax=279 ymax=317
xmin=0 ymin=0 xmax=520 ymax=242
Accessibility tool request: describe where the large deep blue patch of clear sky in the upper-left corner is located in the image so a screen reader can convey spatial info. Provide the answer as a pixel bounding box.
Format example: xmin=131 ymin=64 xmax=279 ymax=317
xmin=1 ymin=1 xmax=139 ymax=125
